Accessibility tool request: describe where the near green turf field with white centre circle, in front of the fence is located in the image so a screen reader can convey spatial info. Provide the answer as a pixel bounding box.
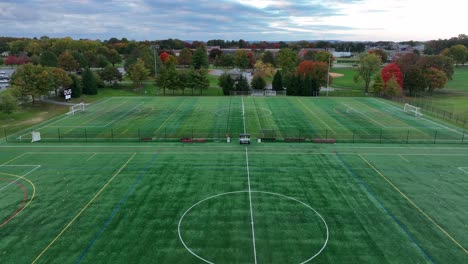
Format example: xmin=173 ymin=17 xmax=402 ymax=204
xmin=0 ymin=143 xmax=468 ymax=263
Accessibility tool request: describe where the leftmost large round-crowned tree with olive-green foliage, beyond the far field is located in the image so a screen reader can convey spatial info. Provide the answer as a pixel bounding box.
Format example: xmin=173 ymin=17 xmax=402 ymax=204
xmin=11 ymin=63 xmax=51 ymax=104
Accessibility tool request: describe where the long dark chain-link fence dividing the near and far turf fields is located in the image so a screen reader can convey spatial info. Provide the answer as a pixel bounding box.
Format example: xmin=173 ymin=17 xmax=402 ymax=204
xmin=3 ymin=128 xmax=468 ymax=144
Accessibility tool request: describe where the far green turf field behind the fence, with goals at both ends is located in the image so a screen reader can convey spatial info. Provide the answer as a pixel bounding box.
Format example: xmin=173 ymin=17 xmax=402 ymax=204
xmin=4 ymin=97 xmax=468 ymax=143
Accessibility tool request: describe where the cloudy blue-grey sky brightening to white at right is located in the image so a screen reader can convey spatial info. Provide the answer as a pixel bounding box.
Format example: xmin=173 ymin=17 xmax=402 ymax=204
xmin=0 ymin=0 xmax=468 ymax=41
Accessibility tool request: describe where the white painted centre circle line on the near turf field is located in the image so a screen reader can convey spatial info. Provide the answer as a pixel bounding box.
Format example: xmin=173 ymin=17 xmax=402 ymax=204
xmin=178 ymin=191 xmax=329 ymax=264
